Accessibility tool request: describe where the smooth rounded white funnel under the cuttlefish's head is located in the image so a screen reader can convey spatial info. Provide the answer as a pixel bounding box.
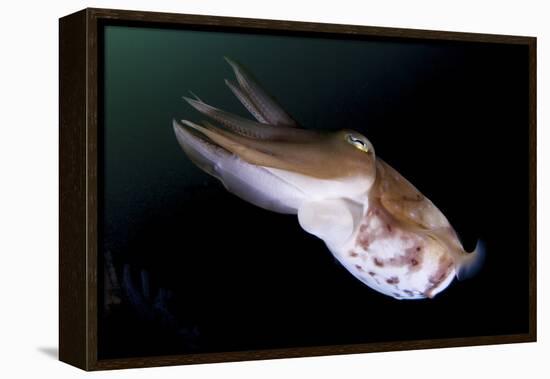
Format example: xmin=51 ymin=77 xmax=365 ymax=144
xmin=298 ymin=198 xmax=363 ymax=246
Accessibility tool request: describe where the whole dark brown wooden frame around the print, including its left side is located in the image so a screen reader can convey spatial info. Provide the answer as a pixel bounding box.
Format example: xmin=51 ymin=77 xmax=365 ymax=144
xmin=59 ymin=8 xmax=537 ymax=370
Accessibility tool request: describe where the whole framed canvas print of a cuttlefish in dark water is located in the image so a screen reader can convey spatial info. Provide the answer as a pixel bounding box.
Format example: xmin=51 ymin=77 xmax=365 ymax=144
xmin=59 ymin=9 xmax=536 ymax=370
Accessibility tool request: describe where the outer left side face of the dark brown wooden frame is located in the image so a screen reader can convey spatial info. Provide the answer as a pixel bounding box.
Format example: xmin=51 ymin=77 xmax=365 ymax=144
xmin=59 ymin=11 xmax=87 ymax=368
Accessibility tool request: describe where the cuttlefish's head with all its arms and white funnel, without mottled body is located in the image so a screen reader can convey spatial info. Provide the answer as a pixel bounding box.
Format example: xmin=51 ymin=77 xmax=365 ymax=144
xmin=173 ymin=58 xmax=377 ymax=249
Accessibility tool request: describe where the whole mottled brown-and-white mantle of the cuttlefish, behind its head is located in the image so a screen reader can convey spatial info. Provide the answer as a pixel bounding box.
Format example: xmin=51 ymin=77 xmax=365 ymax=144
xmin=329 ymin=160 xmax=460 ymax=299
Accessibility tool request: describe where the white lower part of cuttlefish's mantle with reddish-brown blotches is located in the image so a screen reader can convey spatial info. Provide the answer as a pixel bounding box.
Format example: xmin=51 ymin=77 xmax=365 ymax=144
xmin=331 ymin=207 xmax=455 ymax=299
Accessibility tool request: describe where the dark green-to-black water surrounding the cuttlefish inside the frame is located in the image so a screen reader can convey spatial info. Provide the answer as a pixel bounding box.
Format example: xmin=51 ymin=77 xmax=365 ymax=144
xmin=98 ymin=26 xmax=528 ymax=359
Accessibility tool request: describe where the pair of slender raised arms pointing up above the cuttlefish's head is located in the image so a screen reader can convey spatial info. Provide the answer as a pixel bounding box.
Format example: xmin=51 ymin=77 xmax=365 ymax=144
xmin=224 ymin=57 xmax=298 ymax=128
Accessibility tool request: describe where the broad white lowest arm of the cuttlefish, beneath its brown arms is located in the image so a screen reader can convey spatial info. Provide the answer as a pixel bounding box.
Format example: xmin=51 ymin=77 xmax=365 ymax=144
xmin=173 ymin=120 xmax=305 ymax=214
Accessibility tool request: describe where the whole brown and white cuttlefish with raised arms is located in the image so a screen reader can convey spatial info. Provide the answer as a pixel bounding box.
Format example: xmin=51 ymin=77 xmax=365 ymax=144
xmin=173 ymin=58 xmax=484 ymax=299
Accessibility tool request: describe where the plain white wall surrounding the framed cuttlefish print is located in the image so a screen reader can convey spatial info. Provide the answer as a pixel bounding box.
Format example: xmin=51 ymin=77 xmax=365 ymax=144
xmin=0 ymin=0 xmax=550 ymax=379
